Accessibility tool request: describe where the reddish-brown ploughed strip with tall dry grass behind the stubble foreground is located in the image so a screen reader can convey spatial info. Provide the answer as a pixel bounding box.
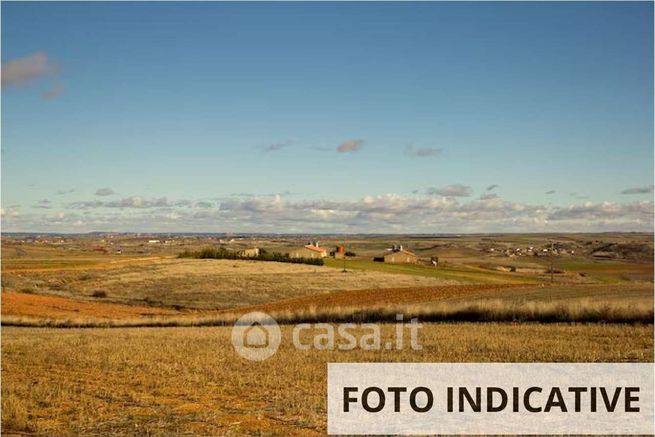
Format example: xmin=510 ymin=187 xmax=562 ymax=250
xmin=2 ymin=283 xmax=653 ymax=327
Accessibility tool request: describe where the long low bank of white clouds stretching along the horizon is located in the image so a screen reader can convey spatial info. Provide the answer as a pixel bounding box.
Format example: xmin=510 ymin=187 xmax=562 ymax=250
xmin=3 ymin=193 xmax=654 ymax=233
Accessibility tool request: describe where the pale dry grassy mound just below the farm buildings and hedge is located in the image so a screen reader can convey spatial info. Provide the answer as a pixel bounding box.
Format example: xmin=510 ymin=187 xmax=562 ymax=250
xmin=3 ymin=257 xmax=457 ymax=309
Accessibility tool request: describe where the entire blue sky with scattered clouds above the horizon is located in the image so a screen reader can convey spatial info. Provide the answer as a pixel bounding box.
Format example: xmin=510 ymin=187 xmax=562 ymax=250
xmin=1 ymin=2 xmax=653 ymax=233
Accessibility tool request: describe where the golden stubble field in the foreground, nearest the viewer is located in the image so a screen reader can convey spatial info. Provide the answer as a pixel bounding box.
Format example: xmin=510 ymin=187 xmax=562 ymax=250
xmin=2 ymin=323 xmax=653 ymax=436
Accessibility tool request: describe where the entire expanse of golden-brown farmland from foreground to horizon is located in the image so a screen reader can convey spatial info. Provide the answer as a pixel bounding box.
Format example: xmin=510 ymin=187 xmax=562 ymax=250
xmin=2 ymin=230 xmax=653 ymax=436
